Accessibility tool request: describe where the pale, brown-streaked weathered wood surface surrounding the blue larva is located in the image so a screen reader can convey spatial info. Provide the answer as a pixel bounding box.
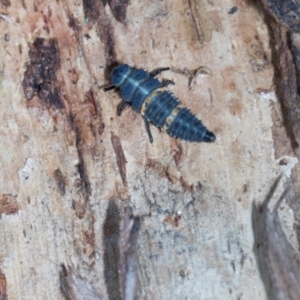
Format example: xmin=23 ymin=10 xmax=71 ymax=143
xmin=0 ymin=0 xmax=298 ymax=300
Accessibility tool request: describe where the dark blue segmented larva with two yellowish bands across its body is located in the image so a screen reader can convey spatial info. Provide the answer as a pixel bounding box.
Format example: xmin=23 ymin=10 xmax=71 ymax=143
xmin=104 ymin=64 xmax=216 ymax=143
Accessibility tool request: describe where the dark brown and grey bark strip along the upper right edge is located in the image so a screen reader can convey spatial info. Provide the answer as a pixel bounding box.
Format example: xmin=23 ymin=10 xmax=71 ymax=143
xmin=262 ymin=0 xmax=300 ymax=155
